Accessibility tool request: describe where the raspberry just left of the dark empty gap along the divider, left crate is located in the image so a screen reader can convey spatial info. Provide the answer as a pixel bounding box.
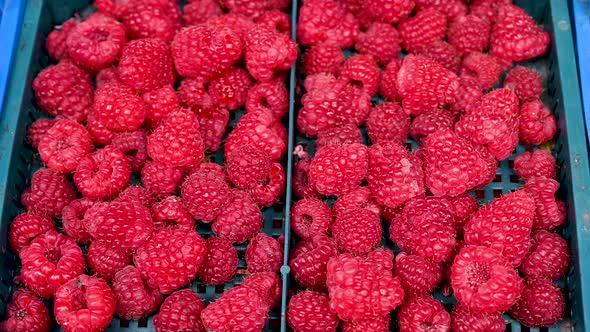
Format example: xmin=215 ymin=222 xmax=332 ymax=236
xmin=211 ymin=189 xmax=263 ymax=243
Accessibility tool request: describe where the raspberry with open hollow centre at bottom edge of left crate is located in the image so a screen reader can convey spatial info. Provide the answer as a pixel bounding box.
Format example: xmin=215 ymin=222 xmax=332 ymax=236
xmin=53 ymin=275 xmax=115 ymax=332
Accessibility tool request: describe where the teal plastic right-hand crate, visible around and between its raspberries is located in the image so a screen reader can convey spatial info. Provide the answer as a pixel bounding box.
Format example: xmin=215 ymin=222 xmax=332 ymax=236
xmin=281 ymin=0 xmax=590 ymax=332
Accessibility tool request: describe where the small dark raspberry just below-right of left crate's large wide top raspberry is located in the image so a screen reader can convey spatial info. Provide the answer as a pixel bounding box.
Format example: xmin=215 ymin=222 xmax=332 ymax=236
xmin=208 ymin=67 xmax=252 ymax=110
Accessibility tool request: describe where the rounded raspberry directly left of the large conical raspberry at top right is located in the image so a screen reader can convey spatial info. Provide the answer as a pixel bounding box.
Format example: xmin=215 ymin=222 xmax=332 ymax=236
xmin=447 ymin=14 xmax=491 ymax=53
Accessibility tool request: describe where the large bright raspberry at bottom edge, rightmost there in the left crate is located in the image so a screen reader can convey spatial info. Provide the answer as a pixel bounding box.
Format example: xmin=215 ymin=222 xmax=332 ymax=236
xmin=201 ymin=286 xmax=268 ymax=331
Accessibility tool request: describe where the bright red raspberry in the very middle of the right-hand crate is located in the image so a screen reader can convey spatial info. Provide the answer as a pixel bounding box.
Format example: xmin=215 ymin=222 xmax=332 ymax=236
xmin=367 ymin=142 xmax=424 ymax=208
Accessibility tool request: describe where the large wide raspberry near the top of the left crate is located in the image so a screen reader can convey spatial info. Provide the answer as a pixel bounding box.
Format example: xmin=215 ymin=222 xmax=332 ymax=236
xmin=172 ymin=23 xmax=244 ymax=80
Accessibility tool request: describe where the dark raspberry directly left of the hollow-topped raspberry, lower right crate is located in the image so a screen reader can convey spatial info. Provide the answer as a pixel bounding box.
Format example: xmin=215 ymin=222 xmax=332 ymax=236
xmin=395 ymin=252 xmax=443 ymax=295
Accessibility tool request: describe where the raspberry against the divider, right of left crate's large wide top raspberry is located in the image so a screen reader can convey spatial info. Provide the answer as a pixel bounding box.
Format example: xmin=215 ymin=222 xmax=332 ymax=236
xmin=244 ymin=25 xmax=297 ymax=82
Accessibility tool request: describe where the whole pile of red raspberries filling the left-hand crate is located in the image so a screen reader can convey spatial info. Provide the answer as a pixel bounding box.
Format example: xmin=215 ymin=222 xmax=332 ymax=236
xmin=0 ymin=0 xmax=298 ymax=332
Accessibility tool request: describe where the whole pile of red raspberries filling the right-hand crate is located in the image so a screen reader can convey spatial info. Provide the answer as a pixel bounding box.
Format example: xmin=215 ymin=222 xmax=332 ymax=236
xmin=287 ymin=0 xmax=570 ymax=332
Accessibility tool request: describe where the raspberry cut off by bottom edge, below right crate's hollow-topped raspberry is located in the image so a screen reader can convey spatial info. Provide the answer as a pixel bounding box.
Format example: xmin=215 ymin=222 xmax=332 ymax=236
xmin=452 ymin=303 xmax=506 ymax=332
